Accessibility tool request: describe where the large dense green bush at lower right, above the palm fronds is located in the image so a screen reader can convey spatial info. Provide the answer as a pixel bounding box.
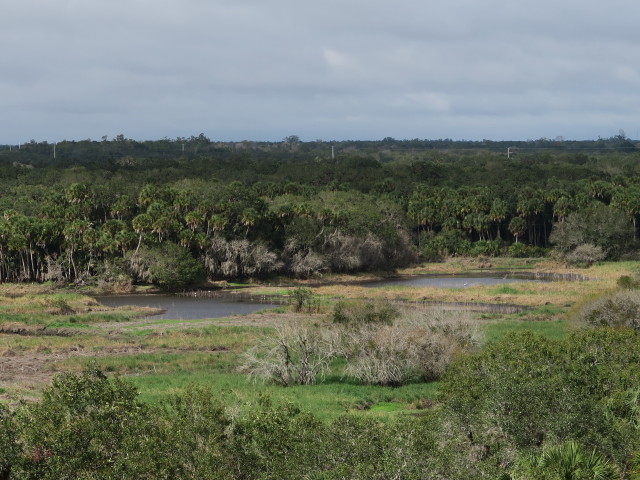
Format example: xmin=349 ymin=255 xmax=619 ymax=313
xmin=439 ymin=330 xmax=640 ymax=472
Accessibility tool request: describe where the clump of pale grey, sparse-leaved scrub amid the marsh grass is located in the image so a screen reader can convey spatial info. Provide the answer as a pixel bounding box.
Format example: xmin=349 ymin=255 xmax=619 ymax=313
xmin=241 ymin=302 xmax=480 ymax=386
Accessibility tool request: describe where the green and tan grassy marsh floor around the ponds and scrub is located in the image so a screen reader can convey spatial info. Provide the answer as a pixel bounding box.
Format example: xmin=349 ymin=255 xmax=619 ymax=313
xmin=0 ymin=259 xmax=640 ymax=419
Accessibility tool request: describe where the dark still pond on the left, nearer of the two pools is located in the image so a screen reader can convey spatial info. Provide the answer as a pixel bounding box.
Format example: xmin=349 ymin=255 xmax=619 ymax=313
xmin=96 ymin=295 xmax=274 ymax=320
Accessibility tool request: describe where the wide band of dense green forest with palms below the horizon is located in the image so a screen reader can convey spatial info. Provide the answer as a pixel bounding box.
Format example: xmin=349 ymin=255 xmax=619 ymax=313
xmin=0 ymin=134 xmax=640 ymax=286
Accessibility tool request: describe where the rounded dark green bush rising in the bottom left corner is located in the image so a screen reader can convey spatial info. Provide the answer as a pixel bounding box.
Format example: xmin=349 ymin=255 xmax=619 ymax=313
xmin=15 ymin=368 xmax=161 ymax=480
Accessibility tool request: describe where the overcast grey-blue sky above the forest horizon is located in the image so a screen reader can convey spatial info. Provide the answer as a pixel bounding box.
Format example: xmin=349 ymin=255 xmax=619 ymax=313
xmin=0 ymin=0 xmax=640 ymax=144
